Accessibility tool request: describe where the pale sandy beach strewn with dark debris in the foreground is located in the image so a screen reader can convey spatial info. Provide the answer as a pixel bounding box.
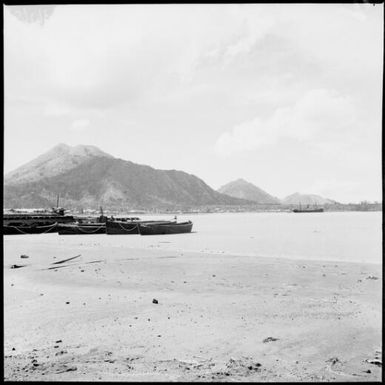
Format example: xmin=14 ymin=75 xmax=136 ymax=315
xmin=4 ymin=235 xmax=382 ymax=381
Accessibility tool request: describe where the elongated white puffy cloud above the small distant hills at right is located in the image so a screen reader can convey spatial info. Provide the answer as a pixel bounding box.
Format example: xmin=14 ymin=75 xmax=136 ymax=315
xmin=215 ymin=89 xmax=356 ymax=156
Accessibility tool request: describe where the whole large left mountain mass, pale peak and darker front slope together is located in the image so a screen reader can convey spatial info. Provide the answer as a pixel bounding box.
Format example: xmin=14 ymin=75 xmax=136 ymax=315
xmin=4 ymin=145 xmax=251 ymax=209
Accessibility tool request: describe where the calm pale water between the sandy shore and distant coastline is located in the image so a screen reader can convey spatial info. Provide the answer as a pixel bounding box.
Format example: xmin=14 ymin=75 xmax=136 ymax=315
xmin=5 ymin=212 xmax=382 ymax=263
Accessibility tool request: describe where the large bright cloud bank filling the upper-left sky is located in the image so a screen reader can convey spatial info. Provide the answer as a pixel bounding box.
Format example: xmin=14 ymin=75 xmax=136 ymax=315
xmin=5 ymin=5 xmax=280 ymax=109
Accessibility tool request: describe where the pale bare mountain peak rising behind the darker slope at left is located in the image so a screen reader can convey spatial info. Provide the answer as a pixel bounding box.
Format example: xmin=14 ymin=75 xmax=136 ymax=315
xmin=4 ymin=143 xmax=112 ymax=184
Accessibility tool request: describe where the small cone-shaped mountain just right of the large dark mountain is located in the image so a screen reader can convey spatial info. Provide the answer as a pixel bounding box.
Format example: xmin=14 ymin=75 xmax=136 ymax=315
xmin=218 ymin=179 xmax=280 ymax=204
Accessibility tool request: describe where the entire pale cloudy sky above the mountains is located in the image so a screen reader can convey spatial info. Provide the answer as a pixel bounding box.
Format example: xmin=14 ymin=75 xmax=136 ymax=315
xmin=4 ymin=3 xmax=384 ymax=203
